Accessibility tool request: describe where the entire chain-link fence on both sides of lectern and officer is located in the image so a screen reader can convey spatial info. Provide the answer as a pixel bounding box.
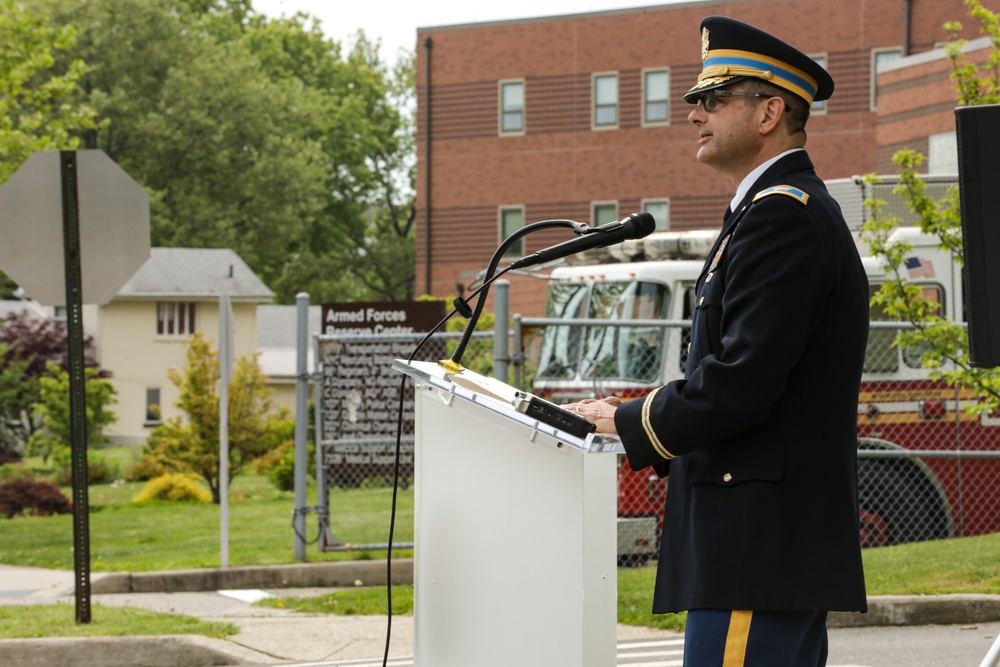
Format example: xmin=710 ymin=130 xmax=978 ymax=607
xmin=319 ymin=317 xmax=1000 ymax=561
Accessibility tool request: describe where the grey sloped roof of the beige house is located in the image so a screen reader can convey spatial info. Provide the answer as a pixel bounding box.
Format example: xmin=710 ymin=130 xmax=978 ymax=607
xmin=115 ymin=248 xmax=274 ymax=301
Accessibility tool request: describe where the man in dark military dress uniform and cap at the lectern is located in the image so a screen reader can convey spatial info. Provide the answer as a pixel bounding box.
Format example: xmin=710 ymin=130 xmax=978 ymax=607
xmin=574 ymin=16 xmax=868 ymax=667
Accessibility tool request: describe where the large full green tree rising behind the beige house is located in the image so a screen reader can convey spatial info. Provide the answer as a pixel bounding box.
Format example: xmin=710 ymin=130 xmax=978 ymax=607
xmin=34 ymin=0 xmax=412 ymax=303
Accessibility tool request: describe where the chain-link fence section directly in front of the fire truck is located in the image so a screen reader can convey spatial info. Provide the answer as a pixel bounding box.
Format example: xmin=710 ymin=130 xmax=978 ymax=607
xmin=520 ymin=319 xmax=1000 ymax=546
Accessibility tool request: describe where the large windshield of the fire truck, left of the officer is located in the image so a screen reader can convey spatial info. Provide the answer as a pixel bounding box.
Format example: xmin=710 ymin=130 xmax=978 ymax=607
xmin=538 ymin=281 xmax=670 ymax=382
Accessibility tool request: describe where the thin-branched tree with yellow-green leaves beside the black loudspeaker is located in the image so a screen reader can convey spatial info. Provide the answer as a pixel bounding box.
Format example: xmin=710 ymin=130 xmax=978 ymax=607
xmin=862 ymin=0 xmax=1000 ymax=414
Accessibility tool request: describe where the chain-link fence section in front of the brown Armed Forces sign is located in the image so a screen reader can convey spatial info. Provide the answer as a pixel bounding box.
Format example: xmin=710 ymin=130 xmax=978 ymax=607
xmin=316 ymin=331 xmax=493 ymax=551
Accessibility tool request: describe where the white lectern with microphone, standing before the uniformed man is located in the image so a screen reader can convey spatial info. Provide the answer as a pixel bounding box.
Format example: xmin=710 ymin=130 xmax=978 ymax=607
xmin=393 ymin=360 xmax=622 ymax=667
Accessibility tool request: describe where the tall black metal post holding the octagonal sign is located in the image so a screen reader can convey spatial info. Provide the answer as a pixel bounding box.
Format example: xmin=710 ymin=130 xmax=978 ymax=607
xmin=59 ymin=151 xmax=90 ymax=623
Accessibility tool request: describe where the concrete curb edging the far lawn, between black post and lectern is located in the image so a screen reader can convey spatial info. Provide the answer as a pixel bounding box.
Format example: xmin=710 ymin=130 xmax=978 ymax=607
xmin=87 ymin=559 xmax=413 ymax=595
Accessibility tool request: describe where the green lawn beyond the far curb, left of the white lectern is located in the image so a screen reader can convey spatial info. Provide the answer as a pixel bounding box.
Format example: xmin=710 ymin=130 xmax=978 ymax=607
xmin=0 ymin=450 xmax=413 ymax=572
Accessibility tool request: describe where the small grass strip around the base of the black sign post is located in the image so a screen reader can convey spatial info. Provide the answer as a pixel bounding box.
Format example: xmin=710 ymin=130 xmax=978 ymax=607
xmin=0 ymin=604 xmax=239 ymax=639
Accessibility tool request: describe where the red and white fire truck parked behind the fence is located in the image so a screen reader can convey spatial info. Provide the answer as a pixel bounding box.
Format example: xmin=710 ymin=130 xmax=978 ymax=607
xmin=534 ymin=179 xmax=1000 ymax=563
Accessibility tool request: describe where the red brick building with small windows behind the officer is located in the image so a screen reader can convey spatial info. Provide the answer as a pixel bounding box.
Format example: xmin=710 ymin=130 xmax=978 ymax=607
xmin=417 ymin=0 xmax=1000 ymax=315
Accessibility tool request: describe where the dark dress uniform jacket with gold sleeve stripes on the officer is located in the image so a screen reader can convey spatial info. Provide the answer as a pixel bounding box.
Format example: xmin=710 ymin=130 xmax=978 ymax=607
xmin=615 ymin=151 xmax=868 ymax=613
